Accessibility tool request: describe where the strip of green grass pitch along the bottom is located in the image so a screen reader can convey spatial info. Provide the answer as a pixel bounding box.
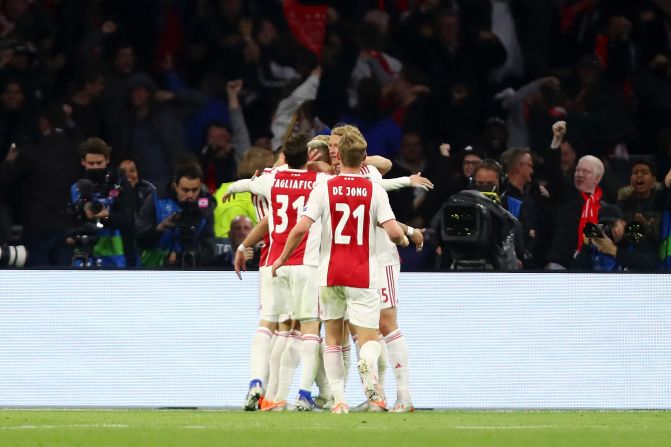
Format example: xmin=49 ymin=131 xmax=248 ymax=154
xmin=0 ymin=410 xmax=671 ymax=447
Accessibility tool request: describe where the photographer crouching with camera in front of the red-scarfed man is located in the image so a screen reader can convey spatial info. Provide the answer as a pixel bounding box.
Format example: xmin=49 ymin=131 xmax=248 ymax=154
xmin=571 ymin=205 xmax=656 ymax=272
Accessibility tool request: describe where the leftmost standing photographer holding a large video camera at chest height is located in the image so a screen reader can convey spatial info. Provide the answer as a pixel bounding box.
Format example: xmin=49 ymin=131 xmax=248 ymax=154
xmin=67 ymin=137 xmax=136 ymax=267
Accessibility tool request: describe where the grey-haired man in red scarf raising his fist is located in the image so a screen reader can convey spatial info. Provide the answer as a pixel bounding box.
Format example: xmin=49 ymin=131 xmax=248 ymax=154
xmin=545 ymin=121 xmax=604 ymax=270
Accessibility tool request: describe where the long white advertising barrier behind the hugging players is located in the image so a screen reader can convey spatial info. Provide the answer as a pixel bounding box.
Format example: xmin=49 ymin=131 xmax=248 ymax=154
xmin=0 ymin=270 xmax=671 ymax=409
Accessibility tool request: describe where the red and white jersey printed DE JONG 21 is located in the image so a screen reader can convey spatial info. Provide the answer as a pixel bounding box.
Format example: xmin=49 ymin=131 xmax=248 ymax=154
xmin=303 ymin=174 xmax=395 ymax=288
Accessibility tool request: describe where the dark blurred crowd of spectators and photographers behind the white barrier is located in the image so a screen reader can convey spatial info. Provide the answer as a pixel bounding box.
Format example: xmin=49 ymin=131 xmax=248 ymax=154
xmin=0 ymin=0 xmax=671 ymax=271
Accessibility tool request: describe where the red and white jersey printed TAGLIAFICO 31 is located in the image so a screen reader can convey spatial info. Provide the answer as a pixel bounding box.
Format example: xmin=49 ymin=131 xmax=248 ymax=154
xmin=243 ymin=169 xmax=329 ymax=265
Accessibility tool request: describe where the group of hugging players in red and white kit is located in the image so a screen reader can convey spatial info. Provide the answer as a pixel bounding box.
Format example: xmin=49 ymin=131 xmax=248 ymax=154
xmin=228 ymin=124 xmax=433 ymax=413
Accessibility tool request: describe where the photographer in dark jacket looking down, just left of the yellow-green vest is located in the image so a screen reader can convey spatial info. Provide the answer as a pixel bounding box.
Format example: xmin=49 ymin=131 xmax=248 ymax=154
xmin=136 ymin=159 xmax=215 ymax=267
